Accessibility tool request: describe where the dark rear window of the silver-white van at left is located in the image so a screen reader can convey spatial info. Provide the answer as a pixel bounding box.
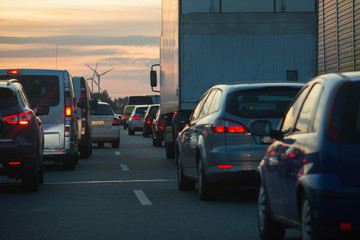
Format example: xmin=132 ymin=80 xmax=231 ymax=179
xmin=0 ymin=75 xmax=60 ymax=107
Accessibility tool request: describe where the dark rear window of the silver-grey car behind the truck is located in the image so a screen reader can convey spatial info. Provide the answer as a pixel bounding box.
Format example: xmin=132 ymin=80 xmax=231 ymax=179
xmin=226 ymin=87 xmax=301 ymax=118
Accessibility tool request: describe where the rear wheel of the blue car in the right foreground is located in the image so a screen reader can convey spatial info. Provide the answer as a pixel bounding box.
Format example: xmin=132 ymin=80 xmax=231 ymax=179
xmin=300 ymin=197 xmax=324 ymax=240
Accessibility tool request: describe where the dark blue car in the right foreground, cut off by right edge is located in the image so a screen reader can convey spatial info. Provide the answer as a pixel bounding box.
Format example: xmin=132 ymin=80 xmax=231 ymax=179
xmin=249 ymin=72 xmax=360 ymax=240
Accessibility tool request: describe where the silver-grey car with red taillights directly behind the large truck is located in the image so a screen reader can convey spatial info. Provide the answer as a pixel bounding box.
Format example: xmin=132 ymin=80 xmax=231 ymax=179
xmin=174 ymin=83 xmax=304 ymax=200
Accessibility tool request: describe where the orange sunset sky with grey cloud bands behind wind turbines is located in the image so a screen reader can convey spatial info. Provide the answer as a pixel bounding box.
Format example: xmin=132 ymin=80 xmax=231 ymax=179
xmin=0 ymin=0 xmax=161 ymax=98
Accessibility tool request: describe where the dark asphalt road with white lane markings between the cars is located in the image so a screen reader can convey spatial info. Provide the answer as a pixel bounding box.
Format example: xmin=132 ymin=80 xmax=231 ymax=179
xmin=0 ymin=130 xmax=300 ymax=240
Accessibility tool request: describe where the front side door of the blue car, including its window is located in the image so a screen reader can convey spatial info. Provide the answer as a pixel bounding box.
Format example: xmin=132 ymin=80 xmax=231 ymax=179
xmin=262 ymin=86 xmax=309 ymax=217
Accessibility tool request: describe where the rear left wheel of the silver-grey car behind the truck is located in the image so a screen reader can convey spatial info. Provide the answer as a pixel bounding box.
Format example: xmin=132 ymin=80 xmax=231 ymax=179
xmin=198 ymin=159 xmax=217 ymax=201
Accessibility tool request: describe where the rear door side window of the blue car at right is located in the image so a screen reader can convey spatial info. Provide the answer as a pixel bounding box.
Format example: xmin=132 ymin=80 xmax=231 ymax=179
xmin=294 ymin=84 xmax=322 ymax=133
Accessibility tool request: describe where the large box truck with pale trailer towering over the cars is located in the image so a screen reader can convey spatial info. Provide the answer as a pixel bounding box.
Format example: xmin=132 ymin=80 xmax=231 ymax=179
xmin=150 ymin=0 xmax=318 ymax=158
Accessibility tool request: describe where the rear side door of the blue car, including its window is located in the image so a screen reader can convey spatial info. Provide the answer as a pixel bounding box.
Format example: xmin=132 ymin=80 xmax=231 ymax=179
xmin=279 ymin=83 xmax=323 ymax=221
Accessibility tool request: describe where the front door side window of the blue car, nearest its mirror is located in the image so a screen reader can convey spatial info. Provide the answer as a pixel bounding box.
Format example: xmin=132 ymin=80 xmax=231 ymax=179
xmin=280 ymin=86 xmax=309 ymax=134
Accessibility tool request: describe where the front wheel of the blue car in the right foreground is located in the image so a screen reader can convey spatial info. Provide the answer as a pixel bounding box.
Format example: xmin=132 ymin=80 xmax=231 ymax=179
xmin=257 ymin=185 xmax=285 ymax=240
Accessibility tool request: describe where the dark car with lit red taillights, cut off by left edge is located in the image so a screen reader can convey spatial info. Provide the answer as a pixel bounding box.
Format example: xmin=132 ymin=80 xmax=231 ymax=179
xmin=0 ymin=79 xmax=49 ymax=191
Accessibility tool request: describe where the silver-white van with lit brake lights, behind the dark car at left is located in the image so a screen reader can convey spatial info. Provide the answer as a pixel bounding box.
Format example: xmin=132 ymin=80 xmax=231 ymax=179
xmin=0 ymin=69 xmax=78 ymax=170
